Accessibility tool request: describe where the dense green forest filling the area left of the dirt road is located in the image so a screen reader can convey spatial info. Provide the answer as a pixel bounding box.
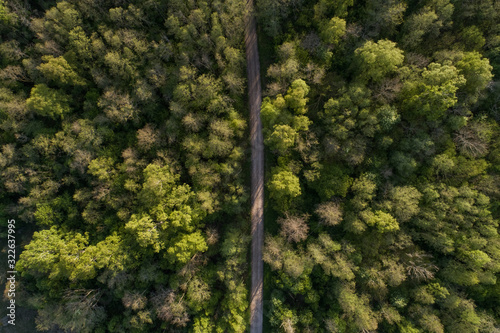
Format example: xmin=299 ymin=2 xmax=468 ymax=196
xmin=6 ymin=1 xmax=250 ymax=332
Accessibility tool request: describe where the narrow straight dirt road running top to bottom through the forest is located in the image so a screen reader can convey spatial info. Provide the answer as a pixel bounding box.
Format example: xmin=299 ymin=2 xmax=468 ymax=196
xmin=245 ymin=0 xmax=264 ymax=333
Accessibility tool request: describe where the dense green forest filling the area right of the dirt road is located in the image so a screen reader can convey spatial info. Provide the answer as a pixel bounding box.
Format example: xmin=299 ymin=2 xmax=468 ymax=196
xmin=261 ymin=0 xmax=500 ymax=333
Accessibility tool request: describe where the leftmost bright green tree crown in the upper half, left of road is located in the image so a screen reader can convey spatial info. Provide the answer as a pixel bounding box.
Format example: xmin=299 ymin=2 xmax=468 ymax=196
xmin=26 ymin=83 xmax=71 ymax=119
